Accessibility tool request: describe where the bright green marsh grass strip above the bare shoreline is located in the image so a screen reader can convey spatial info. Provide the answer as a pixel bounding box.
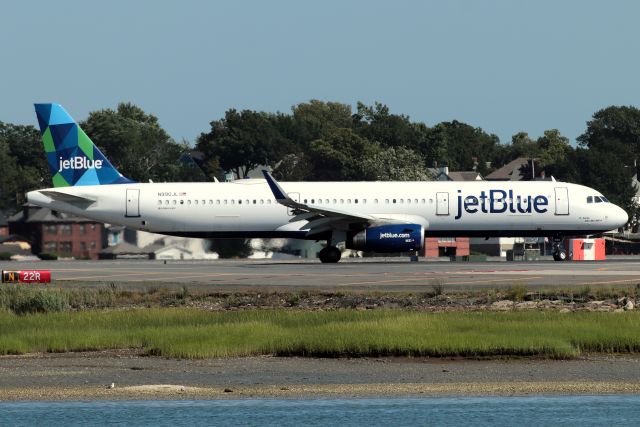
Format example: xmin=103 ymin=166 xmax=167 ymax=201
xmin=0 ymin=308 xmax=640 ymax=358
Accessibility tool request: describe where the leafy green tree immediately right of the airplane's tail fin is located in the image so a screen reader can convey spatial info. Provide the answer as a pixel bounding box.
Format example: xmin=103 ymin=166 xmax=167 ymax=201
xmin=81 ymin=103 xmax=187 ymax=182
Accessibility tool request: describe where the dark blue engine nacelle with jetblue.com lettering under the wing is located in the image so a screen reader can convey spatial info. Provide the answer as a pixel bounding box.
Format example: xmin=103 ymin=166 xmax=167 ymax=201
xmin=347 ymin=224 xmax=424 ymax=253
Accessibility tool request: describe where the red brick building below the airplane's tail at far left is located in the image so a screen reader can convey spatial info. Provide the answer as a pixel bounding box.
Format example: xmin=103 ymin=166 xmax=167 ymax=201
xmin=8 ymin=205 xmax=103 ymax=259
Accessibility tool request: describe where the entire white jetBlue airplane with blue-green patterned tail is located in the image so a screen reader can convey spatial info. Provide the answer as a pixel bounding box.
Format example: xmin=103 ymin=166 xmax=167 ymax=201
xmin=27 ymin=104 xmax=628 ymax=263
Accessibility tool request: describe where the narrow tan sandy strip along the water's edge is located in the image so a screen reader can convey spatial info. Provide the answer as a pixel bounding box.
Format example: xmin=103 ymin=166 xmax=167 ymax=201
xmin=0 ymin=382 xmax=640 ymax=401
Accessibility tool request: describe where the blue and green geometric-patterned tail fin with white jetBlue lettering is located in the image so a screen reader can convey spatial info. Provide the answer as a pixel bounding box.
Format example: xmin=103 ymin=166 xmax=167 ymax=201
xmin=35 ymin=104 xmax=134 ymax=187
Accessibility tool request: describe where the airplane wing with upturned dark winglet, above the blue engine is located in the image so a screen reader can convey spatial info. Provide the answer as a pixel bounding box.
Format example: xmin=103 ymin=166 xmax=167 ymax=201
xmin=262 ymin=170 xmax=426 ymax=236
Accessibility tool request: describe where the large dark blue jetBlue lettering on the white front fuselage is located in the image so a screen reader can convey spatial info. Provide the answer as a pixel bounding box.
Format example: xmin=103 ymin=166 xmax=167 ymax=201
xmin=455 ymin=190 xmax=549 ymax=219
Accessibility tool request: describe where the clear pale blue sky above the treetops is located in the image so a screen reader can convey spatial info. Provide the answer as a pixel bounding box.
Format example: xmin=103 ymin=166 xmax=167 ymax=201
xmin=0 ymin=0 xmax=640 ymax=143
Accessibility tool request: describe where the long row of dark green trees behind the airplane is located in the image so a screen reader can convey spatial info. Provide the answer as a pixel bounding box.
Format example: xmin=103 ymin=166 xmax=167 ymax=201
xmin=0 ymin=100 xmax=640 ymax=224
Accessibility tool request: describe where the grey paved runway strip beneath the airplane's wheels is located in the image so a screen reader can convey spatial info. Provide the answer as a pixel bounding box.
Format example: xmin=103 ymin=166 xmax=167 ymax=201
xmin=0 ymin=258 xmax=640 ymax=291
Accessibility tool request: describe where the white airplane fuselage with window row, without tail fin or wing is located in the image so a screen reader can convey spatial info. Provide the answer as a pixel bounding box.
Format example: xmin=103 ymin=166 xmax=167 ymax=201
xmin=28 ymin=179 xmax=627 ymax=240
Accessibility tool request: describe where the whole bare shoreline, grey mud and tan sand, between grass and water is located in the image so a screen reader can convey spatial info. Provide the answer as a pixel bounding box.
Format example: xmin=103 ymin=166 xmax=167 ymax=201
xmin=0 ymin=350 xmax=640 ymax=401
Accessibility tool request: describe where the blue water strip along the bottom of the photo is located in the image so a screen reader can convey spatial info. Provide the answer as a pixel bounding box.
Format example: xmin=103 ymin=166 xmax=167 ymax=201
xmin=0 ymin=395 xmax=640 ymax=427
